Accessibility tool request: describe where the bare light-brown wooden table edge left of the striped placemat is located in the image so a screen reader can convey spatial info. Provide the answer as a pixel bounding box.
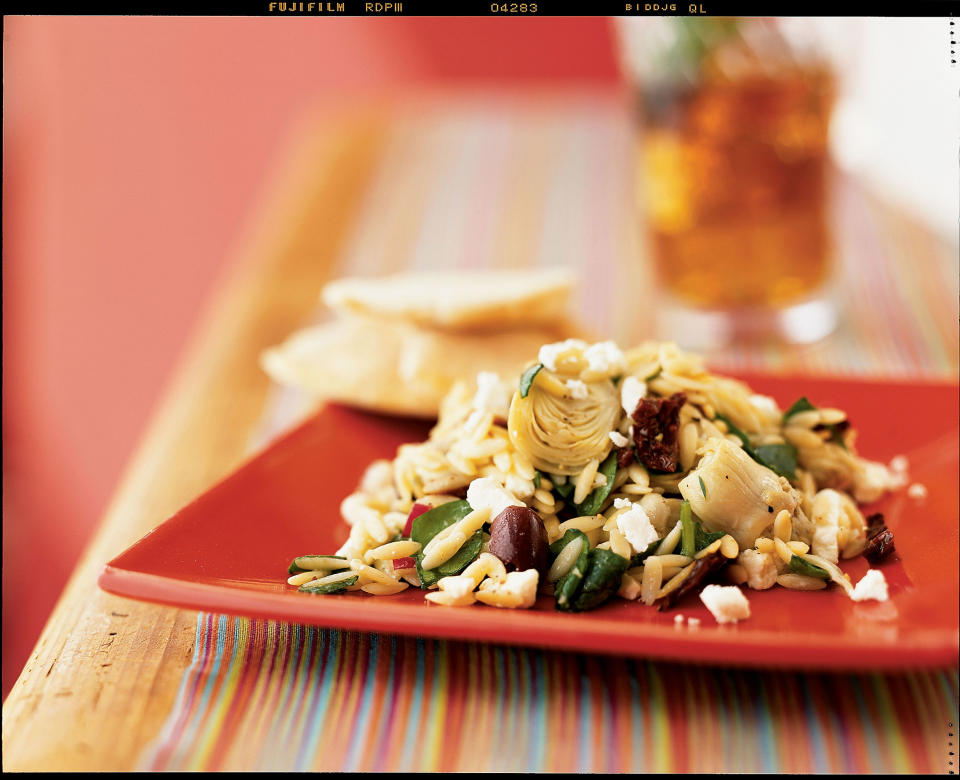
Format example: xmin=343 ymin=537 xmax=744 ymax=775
xmin=3 ymin=106 xmax=386 ymax=771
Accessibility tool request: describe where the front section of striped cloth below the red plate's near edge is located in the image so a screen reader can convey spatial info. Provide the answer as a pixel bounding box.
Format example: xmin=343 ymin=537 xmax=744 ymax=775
xmin=142 ymin=614 xmax=958 ymax=773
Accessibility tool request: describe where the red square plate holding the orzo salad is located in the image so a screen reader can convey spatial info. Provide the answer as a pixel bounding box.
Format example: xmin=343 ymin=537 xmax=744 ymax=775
xmin=99 ymin=376 xmax=960 ymax=669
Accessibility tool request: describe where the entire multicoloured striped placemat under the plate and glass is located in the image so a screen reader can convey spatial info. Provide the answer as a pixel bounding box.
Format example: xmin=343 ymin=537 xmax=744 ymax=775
xmin=141 ymin=96 xmax=958 ymax=773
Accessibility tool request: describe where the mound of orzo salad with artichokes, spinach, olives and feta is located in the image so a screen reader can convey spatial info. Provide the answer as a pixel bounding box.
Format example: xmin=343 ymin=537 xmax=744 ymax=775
xmin=288 ymin=339 xmax=905 ymax=622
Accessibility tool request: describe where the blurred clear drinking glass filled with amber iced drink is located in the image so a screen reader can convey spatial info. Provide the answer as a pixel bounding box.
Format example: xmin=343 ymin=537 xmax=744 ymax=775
xmin=618 ymin=17 xmax=836 ymax=348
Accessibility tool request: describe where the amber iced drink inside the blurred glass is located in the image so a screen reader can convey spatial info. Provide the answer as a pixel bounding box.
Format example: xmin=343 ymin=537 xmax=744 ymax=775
xmin=638 ymin=70 xmax=833 ymax=309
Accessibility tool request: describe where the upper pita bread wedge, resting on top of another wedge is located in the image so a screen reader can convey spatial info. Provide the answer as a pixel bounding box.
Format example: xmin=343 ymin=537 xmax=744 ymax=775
xmin=322 ymin=268 xmax=574 ymax=331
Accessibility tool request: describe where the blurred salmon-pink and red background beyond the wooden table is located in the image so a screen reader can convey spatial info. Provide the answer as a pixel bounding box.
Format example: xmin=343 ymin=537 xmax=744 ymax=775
xmin=3 ymin=17 xmax=618 ymax=697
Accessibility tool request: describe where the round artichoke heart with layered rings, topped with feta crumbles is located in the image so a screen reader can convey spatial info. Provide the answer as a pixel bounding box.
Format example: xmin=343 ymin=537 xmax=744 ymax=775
xmin=507 ymin=368 xmax=620 ymax=476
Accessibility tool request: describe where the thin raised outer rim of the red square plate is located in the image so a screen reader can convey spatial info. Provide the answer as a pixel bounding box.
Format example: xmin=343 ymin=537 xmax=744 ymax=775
xmin=97 ymin=371 xmax=960 ymax=672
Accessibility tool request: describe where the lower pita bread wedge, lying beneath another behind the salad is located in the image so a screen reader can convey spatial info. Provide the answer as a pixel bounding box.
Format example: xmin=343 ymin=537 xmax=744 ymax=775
xmin=260 ymin=317 xmax=571 ymax=418
